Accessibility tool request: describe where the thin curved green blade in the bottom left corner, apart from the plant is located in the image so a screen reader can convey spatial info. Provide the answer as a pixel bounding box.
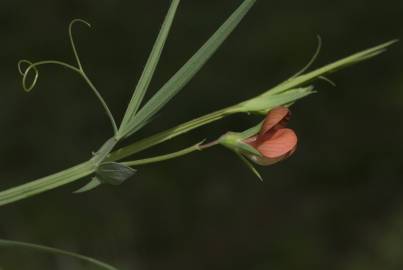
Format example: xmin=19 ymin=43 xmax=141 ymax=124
xmin=0 ymin=239 xmax=118 ymax=270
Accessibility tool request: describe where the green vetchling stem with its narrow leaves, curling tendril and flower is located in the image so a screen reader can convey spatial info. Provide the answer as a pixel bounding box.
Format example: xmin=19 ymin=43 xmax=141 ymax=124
xmin=0 ymin=0 xmax=395 ymax=208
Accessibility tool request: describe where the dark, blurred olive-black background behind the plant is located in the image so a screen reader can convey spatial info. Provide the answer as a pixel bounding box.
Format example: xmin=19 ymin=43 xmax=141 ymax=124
xmin=0 ymin=0 xmax=403 ymax=270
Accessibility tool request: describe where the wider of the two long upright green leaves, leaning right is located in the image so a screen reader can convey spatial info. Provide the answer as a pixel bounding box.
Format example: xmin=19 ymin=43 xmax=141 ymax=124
xmin=123 ymin=0 xmax=256 ymax=136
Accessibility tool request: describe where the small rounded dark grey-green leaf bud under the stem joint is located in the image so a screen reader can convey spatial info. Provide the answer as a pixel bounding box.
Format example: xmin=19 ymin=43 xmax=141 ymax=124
xmin=95 ymin=162 xmax=136 ymax=186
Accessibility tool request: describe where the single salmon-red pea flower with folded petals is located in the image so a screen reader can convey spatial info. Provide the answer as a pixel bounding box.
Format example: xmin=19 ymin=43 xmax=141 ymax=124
xmin=244 ymin=107 xmax=298 ymax=166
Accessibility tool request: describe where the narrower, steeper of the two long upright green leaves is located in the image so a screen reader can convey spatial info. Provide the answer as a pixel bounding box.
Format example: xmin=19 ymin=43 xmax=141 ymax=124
xmin=119 ymin=0 xmax=180 ymax=136
